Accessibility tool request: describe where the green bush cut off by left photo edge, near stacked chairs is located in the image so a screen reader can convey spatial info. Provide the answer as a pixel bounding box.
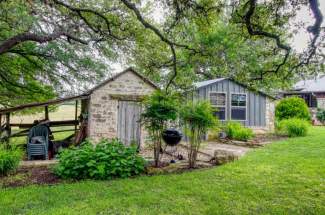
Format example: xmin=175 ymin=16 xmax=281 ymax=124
xmin=0 ymin=146 xmax=22 ymax=176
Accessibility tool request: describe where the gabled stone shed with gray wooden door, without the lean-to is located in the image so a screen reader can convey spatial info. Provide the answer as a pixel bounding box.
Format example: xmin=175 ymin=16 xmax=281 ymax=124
xmin=82 ymin=68 xmax=157 ymax=145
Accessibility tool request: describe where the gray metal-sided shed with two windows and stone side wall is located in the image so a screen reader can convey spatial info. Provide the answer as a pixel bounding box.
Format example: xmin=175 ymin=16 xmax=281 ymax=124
xmin=193 ymin=78 xmax=274 ymax=130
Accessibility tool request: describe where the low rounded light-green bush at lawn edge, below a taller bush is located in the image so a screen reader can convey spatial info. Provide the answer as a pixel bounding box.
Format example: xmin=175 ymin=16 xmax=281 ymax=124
xmin=276 ymin=118 xmax=310 ymax=137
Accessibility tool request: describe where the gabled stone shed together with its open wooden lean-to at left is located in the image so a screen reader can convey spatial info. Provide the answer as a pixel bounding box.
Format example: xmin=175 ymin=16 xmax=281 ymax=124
xmin=0 ymin=68 xmax=158 ymax=151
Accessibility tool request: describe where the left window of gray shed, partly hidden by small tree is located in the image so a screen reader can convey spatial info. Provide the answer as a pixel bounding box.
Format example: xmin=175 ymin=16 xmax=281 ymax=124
xmin=210 ymin=92 xmax=226 ymax=120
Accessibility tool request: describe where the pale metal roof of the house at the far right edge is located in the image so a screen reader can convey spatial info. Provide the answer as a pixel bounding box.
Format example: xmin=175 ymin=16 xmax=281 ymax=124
xmin=293 ymin=75 xmax=325 ymax=92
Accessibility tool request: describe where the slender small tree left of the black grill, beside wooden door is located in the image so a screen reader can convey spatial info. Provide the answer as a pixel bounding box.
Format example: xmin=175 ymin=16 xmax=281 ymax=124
xmin=141 ymin=91 xmax=178 ymax=167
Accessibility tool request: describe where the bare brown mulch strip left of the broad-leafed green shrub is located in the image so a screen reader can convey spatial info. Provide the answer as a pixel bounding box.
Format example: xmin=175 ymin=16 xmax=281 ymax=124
xmin=0 ymin=166 xmax=62 ymax=187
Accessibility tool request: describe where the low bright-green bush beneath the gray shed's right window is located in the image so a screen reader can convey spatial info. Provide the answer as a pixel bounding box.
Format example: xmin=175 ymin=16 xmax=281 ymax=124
xmin=225 ymin=122 xmax=254 ymax=141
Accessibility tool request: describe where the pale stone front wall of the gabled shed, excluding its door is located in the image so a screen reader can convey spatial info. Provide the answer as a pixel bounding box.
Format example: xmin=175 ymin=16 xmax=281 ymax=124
xmin=88 ymin=71 xmax=155 ymax=142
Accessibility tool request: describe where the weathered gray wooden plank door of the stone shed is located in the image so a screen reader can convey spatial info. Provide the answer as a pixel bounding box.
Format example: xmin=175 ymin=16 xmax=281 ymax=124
xmin=117 ymin=101 xmax=141 ymax=146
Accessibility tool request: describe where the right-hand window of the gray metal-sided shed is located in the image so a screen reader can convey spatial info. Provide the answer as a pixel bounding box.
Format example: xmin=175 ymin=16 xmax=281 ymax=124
xmin=231 ymin=94 xmax=247 ymax=120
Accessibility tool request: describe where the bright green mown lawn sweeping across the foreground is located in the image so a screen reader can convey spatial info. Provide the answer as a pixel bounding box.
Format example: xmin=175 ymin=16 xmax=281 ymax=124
xmin=0 ymin=128 xmax=325 ymax=214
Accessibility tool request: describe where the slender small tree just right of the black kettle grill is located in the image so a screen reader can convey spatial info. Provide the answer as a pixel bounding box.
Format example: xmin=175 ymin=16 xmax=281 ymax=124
xmin=180 ymin=101 xmax=217 ymax=168
